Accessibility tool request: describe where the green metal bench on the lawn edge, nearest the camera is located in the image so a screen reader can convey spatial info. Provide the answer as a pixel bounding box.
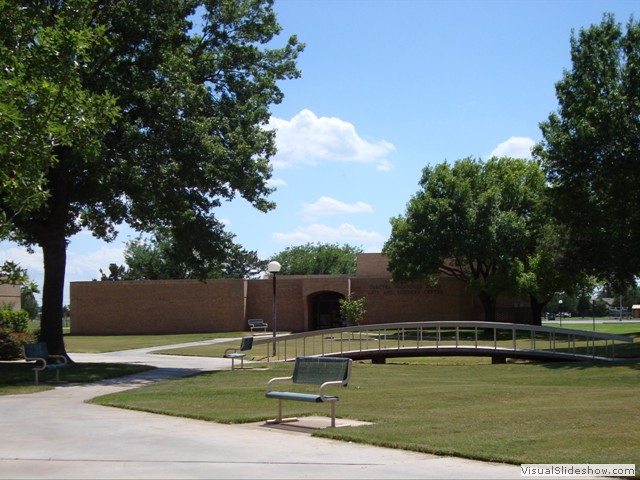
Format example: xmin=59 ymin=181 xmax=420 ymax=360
xmin=266 ymin=357 xmax=352 ymax=427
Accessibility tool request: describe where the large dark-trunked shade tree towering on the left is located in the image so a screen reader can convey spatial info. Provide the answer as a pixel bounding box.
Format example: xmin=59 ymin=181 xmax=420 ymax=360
xmin=0 ymin=0 xmax=302 ymax=354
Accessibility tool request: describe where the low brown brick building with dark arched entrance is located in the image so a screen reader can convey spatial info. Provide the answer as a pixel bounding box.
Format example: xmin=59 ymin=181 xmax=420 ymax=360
xmin=71 ymin=253 xmax=530 ymax=335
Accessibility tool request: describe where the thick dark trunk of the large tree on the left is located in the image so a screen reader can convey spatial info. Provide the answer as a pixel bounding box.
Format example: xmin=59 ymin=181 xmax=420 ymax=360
xmin=40 ymin=229 xmax=68 ymax=358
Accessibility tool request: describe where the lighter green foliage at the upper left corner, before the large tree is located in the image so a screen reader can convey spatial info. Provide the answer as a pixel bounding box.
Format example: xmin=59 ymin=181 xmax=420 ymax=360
xmin=0 ymin=0 xmax=118 ymax=236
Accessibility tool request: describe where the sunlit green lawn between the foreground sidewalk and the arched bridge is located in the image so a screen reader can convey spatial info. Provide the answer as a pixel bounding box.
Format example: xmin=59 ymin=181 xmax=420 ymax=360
xmin=93 ymin=358 xmax=640 ymax=464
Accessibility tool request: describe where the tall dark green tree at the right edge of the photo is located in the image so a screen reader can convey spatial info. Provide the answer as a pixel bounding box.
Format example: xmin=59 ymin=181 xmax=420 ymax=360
xmin=534 ymin=14 xmax=640 ymax=285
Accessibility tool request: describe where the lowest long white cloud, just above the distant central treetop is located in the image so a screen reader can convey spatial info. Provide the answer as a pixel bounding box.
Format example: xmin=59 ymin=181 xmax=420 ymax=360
xmin=273 ymin=223 xmax=384 ymax=245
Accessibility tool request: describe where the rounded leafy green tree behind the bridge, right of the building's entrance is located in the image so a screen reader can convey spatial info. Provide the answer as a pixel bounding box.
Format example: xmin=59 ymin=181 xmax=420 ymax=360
xmin=383 ymin=157 xmax=545 ymax=321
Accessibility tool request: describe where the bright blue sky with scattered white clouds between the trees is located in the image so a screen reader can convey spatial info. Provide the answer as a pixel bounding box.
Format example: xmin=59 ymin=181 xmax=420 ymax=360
xmin=0 ymin=0 xmax=640 ymax=303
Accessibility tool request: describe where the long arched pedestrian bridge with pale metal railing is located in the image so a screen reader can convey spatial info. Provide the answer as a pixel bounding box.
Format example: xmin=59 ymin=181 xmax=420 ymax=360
xmin=253 ymin=322 xmax=633 ymax=363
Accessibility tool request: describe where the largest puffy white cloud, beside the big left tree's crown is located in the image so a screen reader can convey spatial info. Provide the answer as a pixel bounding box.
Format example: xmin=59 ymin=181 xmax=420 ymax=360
xmin=269 ymin=109 xmax=395 ymax=170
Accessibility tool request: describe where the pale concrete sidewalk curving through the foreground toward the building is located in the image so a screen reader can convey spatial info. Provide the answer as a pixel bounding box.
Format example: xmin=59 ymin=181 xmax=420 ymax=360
xmin=0 ymin=339 xmax=520 ymax=479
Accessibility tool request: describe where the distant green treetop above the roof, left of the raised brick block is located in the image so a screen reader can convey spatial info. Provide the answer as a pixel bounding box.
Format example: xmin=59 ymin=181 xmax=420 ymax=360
xmin=272 ymin=243 xmax=362 ymax=275
